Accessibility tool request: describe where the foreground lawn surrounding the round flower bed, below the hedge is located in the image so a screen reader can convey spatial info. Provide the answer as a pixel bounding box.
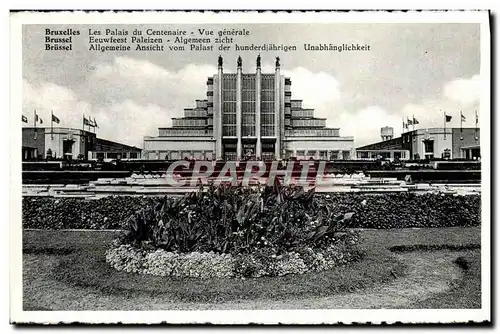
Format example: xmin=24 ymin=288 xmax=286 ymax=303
xmin=23 ymin=227 xmax=481 ymax=309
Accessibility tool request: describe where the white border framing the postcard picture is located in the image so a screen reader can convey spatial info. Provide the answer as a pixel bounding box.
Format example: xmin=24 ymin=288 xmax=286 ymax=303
xmin=9 ymin=11 xmax=491 ymax=324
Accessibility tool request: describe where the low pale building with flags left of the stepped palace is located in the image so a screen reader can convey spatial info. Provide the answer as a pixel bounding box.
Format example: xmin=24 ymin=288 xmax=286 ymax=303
xmin=22 ymin=127 xmax=141 ymax=160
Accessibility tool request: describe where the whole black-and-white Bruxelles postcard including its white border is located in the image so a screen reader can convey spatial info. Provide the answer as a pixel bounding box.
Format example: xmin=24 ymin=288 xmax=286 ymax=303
xmin=10 ymin=11 xmax=491 ymax=324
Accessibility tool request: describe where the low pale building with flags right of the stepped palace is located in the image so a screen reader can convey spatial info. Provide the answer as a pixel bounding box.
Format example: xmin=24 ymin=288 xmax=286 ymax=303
xmin=356 ymin=128 xmax=481 ymax=160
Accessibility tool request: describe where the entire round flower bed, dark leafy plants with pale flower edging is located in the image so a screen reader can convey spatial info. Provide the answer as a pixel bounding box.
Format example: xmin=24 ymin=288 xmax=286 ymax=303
xmin=106 ymin=184 xmax=359 ymax=278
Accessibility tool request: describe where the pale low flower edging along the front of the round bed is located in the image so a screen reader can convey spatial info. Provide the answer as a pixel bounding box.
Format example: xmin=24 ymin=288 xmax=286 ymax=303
xmin=106 ymin=232 xmax=361 ymax=279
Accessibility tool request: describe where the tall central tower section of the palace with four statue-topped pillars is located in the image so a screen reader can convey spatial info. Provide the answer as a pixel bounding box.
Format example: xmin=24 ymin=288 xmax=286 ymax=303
xmin=213 ymin=55 xmax=290 ymax=160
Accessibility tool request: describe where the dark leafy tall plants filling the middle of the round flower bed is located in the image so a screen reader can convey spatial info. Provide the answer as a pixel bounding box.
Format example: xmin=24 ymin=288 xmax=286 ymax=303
xmin=119 ymin=184 xmax=353 ymax=255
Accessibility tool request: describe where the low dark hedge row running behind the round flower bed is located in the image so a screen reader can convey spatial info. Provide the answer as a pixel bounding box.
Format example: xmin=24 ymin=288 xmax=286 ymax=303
xmin=22 ymin=193 xmax=481 ymax=229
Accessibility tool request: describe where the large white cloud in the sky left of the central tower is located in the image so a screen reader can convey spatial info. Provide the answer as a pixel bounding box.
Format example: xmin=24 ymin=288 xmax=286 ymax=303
xmin=23 ymin=57 xmax=216 ymax=147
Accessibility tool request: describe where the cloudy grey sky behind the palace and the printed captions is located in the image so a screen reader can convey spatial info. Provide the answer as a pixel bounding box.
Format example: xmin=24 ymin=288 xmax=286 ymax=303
xmin=23 ymin=23 xmax=480 ymax=147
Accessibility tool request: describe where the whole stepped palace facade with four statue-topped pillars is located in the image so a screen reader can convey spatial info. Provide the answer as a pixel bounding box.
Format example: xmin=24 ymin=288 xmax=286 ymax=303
xmin=144 ymin=56 xmax=355 ymax=160
